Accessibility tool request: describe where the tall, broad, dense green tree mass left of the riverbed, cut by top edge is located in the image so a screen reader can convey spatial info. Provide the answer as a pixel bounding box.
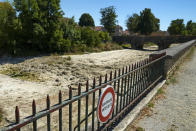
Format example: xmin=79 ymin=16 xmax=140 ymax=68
xmin=14 ymin=0 xmax=66 ymax=52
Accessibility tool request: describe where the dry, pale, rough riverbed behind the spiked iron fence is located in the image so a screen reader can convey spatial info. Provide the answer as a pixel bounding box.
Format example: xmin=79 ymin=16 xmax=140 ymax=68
xmin=0 ymin=49 xmax=155 ymax=126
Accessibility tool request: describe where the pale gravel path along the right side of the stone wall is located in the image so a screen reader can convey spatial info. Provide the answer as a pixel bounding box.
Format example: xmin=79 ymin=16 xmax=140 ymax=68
xmin=136 ymin=52 xmax=196 ymax=131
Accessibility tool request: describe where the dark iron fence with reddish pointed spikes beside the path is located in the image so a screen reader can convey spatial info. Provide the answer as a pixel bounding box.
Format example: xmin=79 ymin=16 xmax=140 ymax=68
xmin=2 ymin=53 xmax=166 ymax=131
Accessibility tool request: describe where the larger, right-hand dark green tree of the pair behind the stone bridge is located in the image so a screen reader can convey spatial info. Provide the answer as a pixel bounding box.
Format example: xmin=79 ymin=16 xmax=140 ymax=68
xmin=137 ymin=8 xmax=160 ymax=35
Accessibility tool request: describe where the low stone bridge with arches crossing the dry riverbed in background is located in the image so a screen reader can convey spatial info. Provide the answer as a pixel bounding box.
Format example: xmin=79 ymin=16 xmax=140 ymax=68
xmin=113 ymin=36 xmax=196 ymax=50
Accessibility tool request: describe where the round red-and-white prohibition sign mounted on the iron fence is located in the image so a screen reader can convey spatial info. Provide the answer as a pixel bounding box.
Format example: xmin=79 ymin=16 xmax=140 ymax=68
xmin=97 ymin=85 xmax=115 ymax=123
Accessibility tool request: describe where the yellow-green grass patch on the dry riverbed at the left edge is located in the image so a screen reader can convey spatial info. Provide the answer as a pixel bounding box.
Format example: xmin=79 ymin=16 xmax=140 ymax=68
xmin=0 ymin=67 xmax=41 ymax=82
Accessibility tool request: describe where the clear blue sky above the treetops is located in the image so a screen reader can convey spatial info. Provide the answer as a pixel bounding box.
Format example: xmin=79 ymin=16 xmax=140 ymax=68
xmin=61 ymin=0 xmax=196 ymax=30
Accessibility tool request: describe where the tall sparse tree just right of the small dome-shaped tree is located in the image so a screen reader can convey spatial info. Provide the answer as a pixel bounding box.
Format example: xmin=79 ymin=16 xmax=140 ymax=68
xmin=100 ymin=6 xmax=117 ymax=35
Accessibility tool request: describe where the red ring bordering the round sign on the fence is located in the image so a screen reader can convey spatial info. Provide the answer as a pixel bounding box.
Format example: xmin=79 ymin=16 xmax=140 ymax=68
xmin=98 ymin=86 xmax=115 ymax=123
